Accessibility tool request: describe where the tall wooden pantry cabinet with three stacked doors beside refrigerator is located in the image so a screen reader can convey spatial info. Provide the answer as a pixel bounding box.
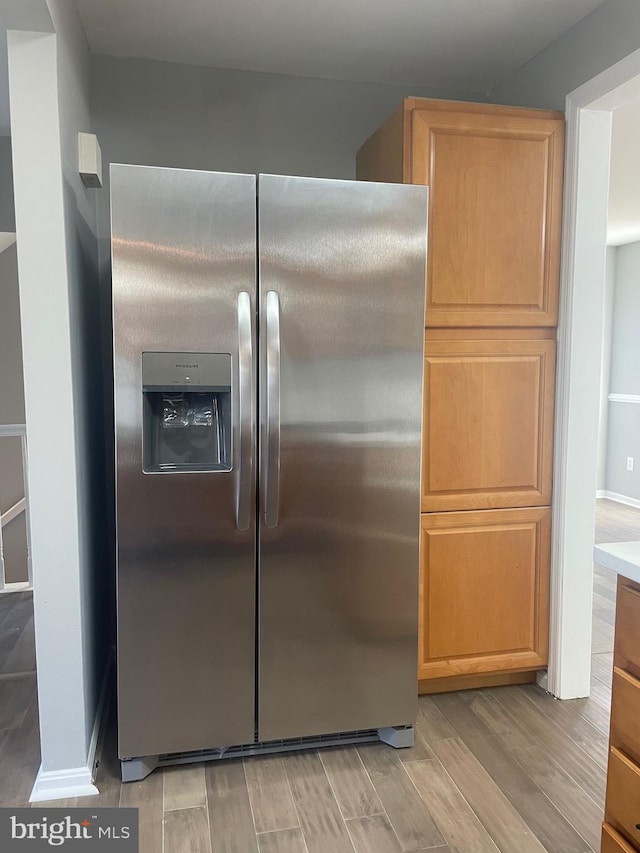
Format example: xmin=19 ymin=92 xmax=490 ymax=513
xmin=356 ymin=98 xmax=564 ymax=692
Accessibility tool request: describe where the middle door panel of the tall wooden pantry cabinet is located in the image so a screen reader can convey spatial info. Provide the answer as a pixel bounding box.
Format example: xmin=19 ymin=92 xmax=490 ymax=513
xmin=422 ymin=340 xmax=555 ymax=512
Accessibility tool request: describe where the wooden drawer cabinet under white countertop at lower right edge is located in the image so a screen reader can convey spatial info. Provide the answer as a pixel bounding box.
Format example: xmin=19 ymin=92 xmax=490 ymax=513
xmin=602 ymin=576 xmax=640 ymax=853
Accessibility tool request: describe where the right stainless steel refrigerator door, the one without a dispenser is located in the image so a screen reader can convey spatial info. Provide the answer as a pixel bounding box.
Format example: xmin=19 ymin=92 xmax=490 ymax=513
xmin=258 ymin=175 xmax=427 ymax=741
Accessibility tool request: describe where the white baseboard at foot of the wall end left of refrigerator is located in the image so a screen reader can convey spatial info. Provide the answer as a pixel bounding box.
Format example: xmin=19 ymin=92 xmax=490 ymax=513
xmin=29 ymin=649 xmax=114 ymax=803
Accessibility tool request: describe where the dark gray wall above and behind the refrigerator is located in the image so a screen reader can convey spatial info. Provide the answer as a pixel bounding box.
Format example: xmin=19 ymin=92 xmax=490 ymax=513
xmin=91 ymin=56 xmax=484 ymax=268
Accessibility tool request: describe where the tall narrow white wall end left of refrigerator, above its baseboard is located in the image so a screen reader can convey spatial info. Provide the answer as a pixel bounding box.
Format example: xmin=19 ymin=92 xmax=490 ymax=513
xmin=8 ymin=26 xmax=86 ymax=770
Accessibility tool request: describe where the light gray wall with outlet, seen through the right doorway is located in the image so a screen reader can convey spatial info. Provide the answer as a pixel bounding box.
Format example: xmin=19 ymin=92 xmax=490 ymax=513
xmin=606 ymin=238 xmax=640 ymax=500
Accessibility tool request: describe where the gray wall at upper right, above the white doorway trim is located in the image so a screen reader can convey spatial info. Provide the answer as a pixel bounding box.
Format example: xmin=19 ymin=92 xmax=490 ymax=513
xmin=489 ymin=0 xmax=640 ymax=111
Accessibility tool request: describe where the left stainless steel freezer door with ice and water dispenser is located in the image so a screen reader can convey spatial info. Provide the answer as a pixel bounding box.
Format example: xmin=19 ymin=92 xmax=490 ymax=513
xmin=111 ymin=166 xmax=256 ymax=758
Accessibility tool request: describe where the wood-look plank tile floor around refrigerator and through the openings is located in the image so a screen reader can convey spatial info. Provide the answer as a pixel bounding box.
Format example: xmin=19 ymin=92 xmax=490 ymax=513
xmin=0 ymin=501 xmax=640 ymax=853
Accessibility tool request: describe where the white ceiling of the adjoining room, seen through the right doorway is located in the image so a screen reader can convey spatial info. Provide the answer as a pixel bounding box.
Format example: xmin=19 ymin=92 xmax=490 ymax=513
xmin=607 ymin=97 xmax=640 ymax=246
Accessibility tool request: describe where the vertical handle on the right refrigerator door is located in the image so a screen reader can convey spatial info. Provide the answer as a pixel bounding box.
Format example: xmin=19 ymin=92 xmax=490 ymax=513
xmin=264 ymin=290 xmax=280 ymax=527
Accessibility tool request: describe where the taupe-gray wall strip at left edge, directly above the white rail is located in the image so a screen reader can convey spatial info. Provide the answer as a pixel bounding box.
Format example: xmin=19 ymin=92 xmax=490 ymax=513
xmin=0 ymin=238 xmax=24 ymax=424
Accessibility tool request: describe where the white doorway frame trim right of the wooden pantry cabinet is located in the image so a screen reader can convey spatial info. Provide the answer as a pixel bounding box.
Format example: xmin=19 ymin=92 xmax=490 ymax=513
xmin=546 ymin=45 xmax=640 ymax=699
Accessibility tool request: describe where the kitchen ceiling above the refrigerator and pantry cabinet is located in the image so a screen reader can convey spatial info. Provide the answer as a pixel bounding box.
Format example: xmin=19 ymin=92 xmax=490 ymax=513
xmin=78 ymin=0 xmax=603 ymax=94
